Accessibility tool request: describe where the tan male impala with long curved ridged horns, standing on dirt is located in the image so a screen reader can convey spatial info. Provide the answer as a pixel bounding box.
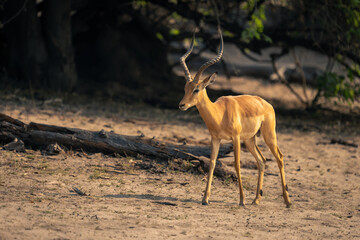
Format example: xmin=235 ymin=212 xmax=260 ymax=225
xmin=179 ymin=28 xmax=291 ymax=207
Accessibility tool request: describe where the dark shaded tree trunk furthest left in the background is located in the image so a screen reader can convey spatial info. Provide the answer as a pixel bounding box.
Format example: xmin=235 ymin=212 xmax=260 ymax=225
xmin=4 ymin=0 xmax=47 ymax=87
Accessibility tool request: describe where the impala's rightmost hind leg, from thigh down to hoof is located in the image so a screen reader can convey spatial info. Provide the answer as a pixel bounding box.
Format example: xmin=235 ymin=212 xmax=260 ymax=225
xmin=261 ymin=121 xmax=291 ymax=208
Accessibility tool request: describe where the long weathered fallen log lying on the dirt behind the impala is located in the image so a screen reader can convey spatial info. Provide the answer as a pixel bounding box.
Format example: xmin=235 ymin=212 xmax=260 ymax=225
xmin=0 ymin=113 xmax=234 ymax=177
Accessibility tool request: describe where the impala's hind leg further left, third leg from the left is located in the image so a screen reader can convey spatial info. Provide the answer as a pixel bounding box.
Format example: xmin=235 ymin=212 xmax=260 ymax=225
xmin=244 ymin=136 xmax=266 ymax=205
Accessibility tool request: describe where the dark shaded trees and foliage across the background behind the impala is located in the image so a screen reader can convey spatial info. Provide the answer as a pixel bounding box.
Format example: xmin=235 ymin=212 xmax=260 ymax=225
xmin=0 ymin=0 xmax=360 ymax=107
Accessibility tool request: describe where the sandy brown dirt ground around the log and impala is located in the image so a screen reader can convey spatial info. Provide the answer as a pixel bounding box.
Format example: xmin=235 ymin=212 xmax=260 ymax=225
xmin=0 ymin=76 xmax=360 ymax=239
